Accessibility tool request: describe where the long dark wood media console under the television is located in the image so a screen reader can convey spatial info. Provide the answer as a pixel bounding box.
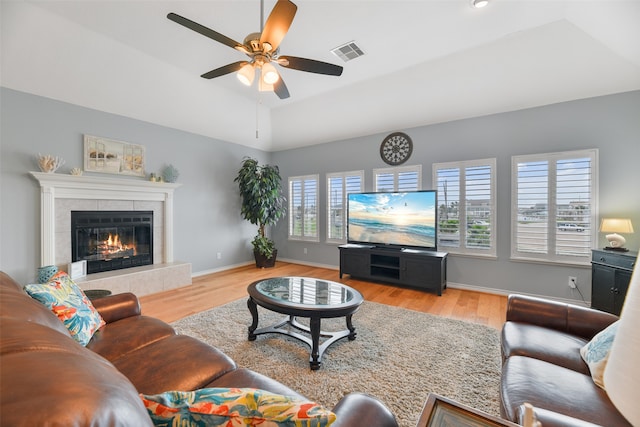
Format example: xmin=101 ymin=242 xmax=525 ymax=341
xmin=339 ymin=244 xmax=449 ymax=295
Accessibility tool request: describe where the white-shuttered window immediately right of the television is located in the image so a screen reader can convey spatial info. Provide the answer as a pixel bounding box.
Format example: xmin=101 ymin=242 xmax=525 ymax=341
xmin=433 ymin=159 xmax=496 ymax=256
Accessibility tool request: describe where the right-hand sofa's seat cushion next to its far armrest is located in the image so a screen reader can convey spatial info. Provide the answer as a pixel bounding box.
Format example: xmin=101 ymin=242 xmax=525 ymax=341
xmin=500 ymin=322 xmax=589 ymax=375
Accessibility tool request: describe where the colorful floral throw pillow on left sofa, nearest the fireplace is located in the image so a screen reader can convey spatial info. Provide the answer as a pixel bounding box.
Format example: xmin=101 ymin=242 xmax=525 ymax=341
xmin=24 ymin=271 xmax=105 ymax=346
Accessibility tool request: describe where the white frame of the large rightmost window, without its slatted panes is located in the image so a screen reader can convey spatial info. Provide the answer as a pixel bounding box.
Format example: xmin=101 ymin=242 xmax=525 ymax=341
xmin=511 ymin=148 xmax=599 ymax=266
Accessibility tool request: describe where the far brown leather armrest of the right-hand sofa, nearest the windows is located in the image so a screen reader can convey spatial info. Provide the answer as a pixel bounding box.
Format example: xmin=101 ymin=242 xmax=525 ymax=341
xmin=506 ymin=294 xmax=618 ymax=340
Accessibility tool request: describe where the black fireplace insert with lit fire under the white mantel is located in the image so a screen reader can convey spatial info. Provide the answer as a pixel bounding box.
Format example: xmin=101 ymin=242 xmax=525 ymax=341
xmin=71 ymin=211 xmax=153 ymax=274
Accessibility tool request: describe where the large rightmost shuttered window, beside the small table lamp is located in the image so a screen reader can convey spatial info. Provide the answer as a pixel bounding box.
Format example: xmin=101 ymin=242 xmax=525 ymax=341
xmin=511 ymin=150 xmax=598 ymax=264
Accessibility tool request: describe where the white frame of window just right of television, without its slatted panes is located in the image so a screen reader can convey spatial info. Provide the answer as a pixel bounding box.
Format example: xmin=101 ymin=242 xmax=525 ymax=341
xmin=432 ymin=157 xmax=498 ymax=258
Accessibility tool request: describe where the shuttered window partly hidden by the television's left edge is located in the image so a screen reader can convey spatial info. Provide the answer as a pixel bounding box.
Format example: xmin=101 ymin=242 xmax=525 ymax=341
xmin=327 ymin=171 xmax=364 ymax=243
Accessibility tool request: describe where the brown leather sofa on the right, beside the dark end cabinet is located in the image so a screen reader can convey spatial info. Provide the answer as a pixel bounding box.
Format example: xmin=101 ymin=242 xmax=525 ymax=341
xmin=500 ymin=295 xmax=631 ymax=427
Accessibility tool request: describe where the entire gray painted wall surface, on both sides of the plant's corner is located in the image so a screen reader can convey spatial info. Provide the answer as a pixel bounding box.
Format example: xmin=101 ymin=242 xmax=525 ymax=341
xmin=0 ymin=88 xmax=640 ymax=300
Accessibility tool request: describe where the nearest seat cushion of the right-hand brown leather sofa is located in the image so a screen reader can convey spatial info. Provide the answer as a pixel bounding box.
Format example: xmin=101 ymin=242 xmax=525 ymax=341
xmin=500 ymin=356 xmax=630 ymax=426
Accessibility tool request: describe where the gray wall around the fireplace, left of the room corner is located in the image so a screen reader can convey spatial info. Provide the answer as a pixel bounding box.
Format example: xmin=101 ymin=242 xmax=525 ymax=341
xmin=0 ymin=88 xmax=269 ymax=283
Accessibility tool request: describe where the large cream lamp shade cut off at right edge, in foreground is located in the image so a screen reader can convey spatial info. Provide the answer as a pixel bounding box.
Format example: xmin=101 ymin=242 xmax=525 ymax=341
xmin=604 ymin=265 xmax=640 ymax=426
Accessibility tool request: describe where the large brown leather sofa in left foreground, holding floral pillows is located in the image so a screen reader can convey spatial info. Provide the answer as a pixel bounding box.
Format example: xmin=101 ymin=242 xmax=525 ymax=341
xmin=0 ymin=272 xmax=398 ymax=427
